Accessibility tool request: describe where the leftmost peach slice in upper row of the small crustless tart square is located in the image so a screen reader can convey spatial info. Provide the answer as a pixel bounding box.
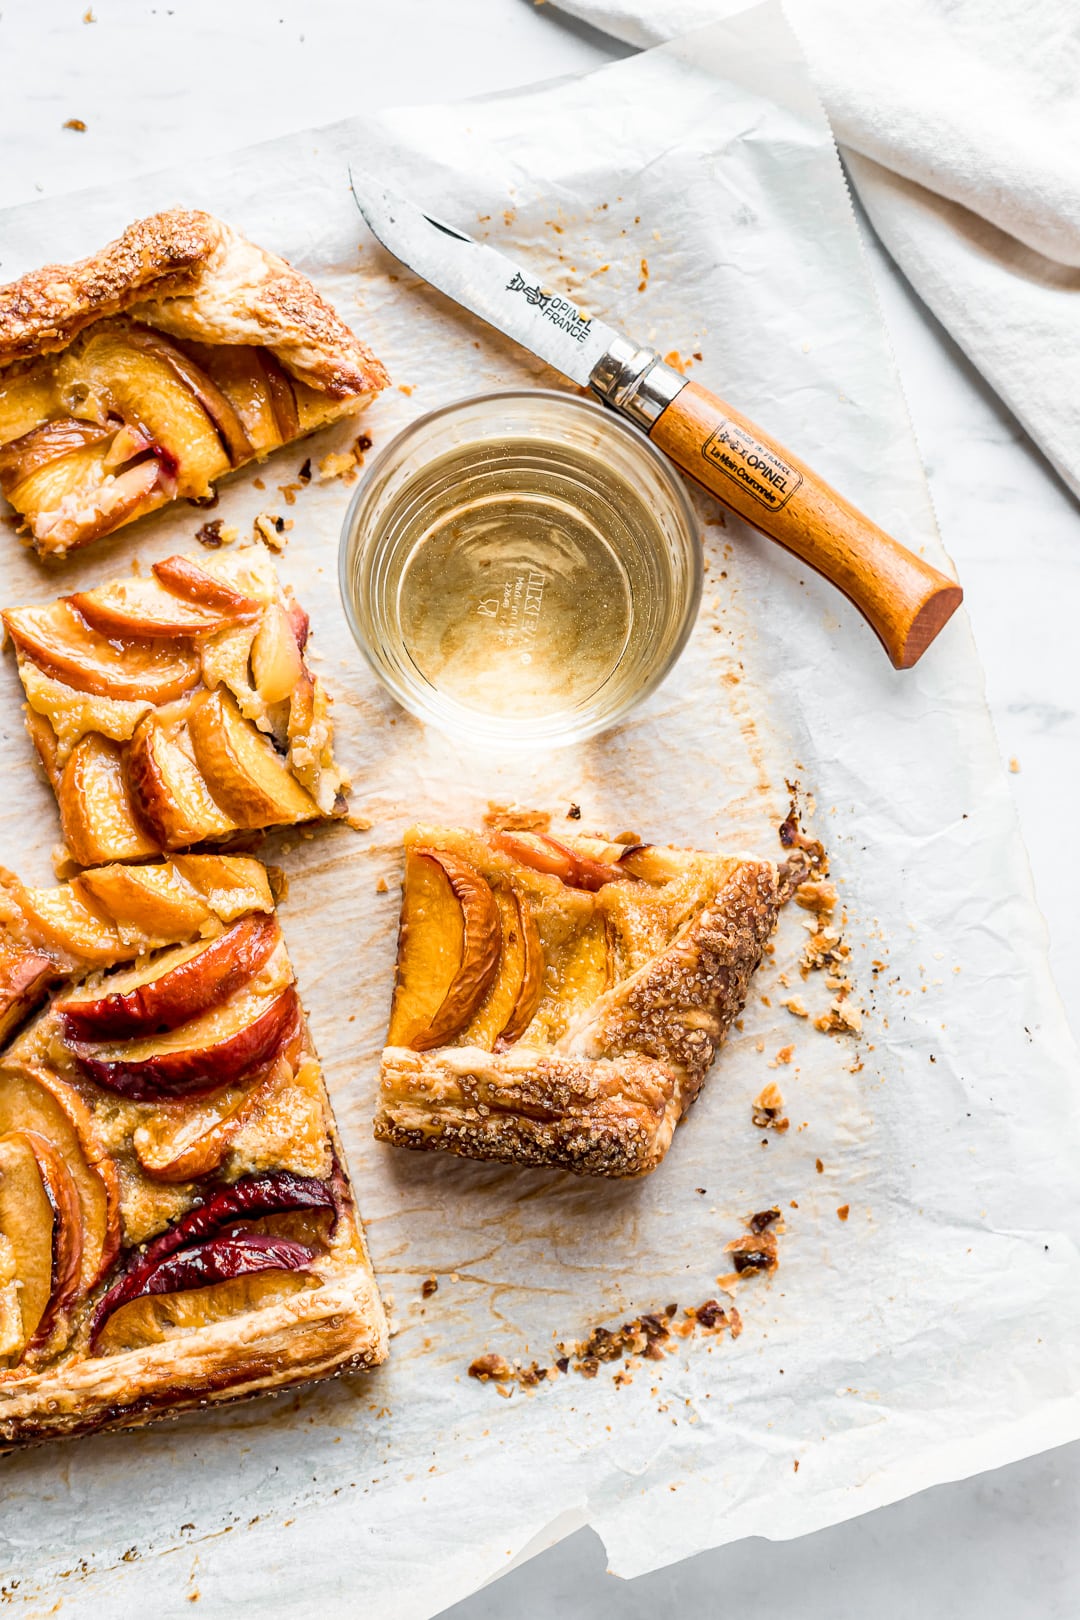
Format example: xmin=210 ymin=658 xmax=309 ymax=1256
xmin=2 ymin=601 xmax=199 ymax=703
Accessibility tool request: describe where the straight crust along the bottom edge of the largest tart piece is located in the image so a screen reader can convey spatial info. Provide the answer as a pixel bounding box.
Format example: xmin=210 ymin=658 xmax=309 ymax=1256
xmin=0 ymin=1265 xmax=387 ymax=1450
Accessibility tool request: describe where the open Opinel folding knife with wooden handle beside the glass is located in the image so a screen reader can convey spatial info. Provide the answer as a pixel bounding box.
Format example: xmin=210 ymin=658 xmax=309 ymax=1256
xmin=350 ymin=168 xmax=963 ymax=669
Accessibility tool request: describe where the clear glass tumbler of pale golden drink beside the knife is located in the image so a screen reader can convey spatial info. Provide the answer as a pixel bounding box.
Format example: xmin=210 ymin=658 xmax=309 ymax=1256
xmin=338 ymin=389 xmax=703 ymax=748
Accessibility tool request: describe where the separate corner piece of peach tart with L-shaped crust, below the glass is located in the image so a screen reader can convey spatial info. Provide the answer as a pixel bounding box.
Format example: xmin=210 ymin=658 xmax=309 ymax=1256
xmin=376 ymin=826 xmax=805 ymax=1176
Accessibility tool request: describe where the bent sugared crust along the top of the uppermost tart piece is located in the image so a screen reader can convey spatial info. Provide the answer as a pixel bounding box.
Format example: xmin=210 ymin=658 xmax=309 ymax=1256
xmin=0 ymin=209 xmax=389 ymax=399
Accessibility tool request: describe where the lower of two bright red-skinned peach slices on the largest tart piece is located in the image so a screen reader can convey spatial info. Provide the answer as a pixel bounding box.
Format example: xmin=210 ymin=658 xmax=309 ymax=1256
xmin=71 ymin=985 xmax=303 ymax=1102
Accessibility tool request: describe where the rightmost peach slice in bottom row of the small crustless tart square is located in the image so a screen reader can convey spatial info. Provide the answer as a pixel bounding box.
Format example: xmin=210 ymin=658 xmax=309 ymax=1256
xmin=188 ymin=687 xmax=321 ymax=826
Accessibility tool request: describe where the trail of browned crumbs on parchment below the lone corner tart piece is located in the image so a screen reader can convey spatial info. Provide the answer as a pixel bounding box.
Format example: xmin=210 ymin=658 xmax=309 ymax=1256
xmin=468 ymin=1207 xmax=784 ymax=1400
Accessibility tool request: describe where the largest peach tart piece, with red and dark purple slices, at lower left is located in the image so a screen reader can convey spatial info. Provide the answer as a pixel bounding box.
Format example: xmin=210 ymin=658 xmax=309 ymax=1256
xmin=0 ymin=855 xmax=385 ymax=1445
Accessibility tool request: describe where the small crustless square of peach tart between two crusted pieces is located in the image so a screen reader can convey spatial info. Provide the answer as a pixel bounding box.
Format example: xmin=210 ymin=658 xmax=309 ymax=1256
xmin=3 ymin=546 xmax=343 ymax=867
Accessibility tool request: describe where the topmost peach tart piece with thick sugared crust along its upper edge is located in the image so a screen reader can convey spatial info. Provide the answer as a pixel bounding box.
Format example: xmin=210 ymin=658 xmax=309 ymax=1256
xmin=0 ymin=209 xmax=387 ymax=556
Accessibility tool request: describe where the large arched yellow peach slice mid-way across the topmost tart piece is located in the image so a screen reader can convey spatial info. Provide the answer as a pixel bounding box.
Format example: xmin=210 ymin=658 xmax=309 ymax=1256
xmin=57 ymin=321 xmax=234 ymax=499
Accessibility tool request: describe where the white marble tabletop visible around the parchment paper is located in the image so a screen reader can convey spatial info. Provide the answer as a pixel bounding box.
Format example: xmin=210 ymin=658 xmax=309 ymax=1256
xmin=0 ymin=0 xmax=1080 ymax=1620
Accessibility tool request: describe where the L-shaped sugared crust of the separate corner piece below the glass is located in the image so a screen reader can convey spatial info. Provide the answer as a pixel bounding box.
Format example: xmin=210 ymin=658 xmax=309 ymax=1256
xmin=374 ymin=860 xmax=785 ymax=1178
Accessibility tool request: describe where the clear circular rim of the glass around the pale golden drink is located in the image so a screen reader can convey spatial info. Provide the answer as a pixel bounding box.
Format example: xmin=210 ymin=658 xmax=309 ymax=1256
xmin=337 ymin=387 xmax=704 ymax=752
